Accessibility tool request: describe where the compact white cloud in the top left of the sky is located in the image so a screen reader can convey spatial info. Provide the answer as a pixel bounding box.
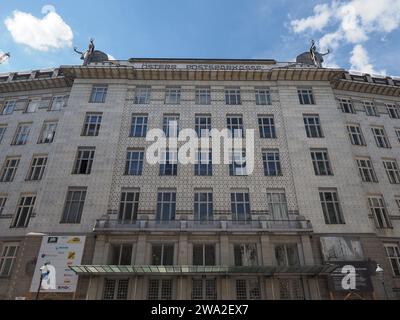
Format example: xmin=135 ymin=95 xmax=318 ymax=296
xmin=4 ymin=5 xmax=74 ymax=51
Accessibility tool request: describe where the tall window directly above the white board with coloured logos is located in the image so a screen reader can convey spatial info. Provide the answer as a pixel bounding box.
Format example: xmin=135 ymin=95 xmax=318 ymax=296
xmin=60 ymin=188 xmax=86 ymax=224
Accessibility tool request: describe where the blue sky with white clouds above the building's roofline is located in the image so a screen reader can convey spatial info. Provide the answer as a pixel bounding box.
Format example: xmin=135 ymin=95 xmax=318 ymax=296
xmin=0 ymin=0 xmax=400 ymax=75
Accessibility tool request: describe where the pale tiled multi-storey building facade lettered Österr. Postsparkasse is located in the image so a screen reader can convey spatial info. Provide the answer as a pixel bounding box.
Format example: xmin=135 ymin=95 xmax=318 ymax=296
xmin=0 ymin=59 xmax=400 ymax=300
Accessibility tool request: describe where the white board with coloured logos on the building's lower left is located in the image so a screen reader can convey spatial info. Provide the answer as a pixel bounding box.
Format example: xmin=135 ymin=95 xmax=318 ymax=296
xmin=30 ymin=236 xmax=86 ymax=293
